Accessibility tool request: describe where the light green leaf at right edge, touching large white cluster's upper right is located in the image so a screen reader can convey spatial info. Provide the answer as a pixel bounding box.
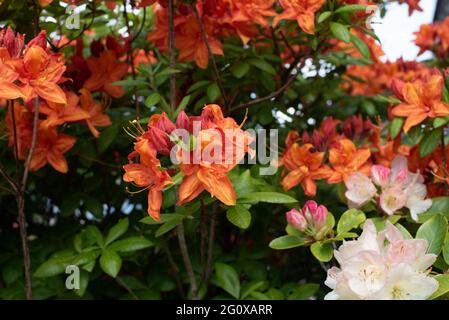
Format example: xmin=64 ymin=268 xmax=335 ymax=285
xmin=416 ymin=214 xmax=447 ymax=255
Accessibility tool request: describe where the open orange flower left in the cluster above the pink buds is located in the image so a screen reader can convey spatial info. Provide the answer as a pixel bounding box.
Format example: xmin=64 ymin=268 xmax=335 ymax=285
xmin=280 ymin=143 xmax=331 ymax=197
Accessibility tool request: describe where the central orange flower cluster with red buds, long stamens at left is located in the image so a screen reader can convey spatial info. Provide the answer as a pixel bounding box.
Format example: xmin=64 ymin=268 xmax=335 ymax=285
xmin=123 ymin=104 xmax=253 ymax=220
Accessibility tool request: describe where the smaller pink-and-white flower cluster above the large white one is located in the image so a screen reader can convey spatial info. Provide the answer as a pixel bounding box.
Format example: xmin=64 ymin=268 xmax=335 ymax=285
xmin=345 ymin=156 xmax=432 ymax=221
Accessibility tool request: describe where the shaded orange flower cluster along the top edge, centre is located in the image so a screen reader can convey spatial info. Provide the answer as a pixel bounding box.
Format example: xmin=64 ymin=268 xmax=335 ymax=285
xmin=148 ymin=0 xmax=325 ymax=68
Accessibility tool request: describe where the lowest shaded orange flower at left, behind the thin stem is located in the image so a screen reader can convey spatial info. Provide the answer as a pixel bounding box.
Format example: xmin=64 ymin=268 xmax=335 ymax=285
xmin=30 ymin=125 xmax=76 ymax=173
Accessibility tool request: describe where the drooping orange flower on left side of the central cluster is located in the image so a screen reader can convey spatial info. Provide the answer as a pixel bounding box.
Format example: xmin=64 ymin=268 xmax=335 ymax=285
xmin=123 ymin=137 xmax=173 ymax=221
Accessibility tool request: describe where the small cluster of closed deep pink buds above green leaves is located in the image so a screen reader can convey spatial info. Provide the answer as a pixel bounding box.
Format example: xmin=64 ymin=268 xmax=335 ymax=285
xmin=286 ymin=200 xmax=327 ymax=237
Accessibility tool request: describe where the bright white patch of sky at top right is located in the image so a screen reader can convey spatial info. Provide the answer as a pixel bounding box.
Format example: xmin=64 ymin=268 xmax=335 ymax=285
xmin=372 ymin=0 xmax=437 ymax=61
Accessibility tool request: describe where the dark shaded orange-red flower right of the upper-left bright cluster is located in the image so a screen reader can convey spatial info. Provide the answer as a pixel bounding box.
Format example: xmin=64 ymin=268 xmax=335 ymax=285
xmin=84 ymin=50 xmax=128 ymax=98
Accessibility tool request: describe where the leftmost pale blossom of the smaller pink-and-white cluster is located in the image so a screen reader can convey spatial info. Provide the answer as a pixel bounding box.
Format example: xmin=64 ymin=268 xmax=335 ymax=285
xmin=345 ymin=172 xmax=377 ymax=208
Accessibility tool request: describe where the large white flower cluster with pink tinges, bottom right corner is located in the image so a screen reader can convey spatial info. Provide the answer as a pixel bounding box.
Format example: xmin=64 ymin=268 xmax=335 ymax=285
xmin=325 ymin=220 xmax=438 ymax=300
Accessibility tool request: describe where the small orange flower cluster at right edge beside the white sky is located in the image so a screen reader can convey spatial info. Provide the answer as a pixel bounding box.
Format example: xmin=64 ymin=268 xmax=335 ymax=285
xmin=415 ymin=17 xmax=449 ymax=59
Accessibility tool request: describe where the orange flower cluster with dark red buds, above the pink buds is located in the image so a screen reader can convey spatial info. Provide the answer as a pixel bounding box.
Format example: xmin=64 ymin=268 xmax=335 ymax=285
xmin=279 ymin=116 xmax=372 ymax=197
